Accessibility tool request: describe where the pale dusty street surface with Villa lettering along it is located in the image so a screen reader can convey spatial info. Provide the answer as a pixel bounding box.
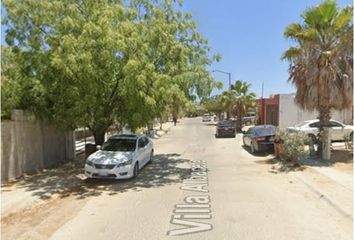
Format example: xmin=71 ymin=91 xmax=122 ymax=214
xmin=6 ymin=118 xmax=352 ymax=240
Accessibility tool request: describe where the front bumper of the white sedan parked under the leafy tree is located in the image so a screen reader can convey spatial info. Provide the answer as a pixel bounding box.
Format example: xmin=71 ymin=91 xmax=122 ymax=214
xmin=85 ymin=164 xmax=134 ymax=179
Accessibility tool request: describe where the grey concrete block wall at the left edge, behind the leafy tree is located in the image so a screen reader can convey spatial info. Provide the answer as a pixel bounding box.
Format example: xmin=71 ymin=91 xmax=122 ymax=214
xmin=1 ymin=110 xmax=75 ymax=183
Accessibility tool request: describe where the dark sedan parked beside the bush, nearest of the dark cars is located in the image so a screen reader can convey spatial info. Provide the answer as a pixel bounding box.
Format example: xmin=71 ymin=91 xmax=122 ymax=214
xmin=243 ymin=125 xmax=275 ymax=153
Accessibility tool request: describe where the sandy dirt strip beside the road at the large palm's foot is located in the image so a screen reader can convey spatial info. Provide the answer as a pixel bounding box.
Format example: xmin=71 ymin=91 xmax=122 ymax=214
xmin=256 ymin=149 xmax=353 ymax=221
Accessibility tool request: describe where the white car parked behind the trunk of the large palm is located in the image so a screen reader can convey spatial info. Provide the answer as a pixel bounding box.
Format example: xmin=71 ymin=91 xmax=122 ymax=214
xmin=287 ymin=119 xmax=354 ymax=142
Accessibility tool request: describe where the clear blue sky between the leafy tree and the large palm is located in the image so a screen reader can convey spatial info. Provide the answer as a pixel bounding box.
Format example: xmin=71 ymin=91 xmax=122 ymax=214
xmin=184 ymin=0 xmax=352 ymax=97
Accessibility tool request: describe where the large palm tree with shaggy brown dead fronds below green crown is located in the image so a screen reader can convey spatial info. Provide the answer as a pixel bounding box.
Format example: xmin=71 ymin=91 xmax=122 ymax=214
xmin=282 ymin=0 xmax=353 ymax=160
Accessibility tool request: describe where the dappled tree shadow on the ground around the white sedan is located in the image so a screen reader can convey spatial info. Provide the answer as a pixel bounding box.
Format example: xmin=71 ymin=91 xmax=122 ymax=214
xmin=2 ymin=153 xmax=191 ymax=200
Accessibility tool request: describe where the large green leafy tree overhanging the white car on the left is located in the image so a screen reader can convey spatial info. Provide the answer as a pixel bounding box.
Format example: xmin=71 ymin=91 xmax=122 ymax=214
xmin=3 ymin=0 xmax=219 ymax=144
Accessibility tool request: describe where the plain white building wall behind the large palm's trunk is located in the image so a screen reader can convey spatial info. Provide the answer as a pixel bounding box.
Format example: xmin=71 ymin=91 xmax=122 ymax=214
xmin=279 ymin=93 xmax=353 ymax=127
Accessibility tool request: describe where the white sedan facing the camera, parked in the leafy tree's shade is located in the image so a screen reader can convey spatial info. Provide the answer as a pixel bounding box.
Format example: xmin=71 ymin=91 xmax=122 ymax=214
xmin=85 ymin=134 xmax=154 ymax=179
